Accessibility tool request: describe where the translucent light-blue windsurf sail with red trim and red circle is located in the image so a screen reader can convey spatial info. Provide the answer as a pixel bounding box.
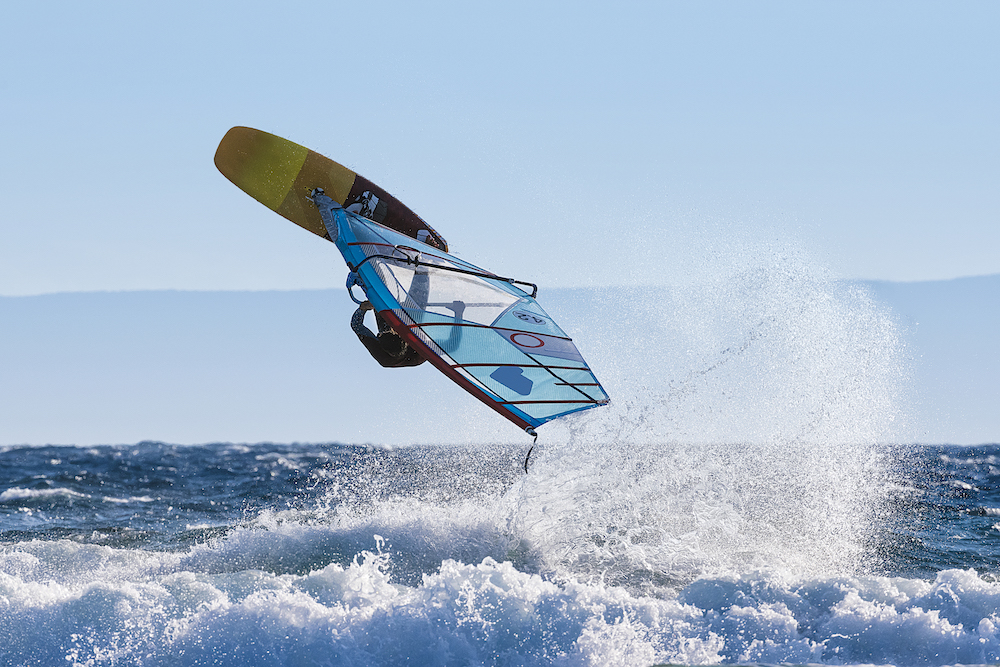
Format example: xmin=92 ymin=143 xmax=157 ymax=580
xmin=312 ymin=190 xmax=608 ymax=434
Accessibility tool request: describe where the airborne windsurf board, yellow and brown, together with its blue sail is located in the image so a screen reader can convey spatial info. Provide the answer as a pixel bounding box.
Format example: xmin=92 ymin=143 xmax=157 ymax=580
xmin=215 ymin=127 xmax=608 ymax=436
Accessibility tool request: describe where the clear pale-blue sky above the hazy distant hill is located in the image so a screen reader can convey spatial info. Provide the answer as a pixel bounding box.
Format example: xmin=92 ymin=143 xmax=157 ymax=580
xmin=0 ymin=0 xmax=1000 ymax=296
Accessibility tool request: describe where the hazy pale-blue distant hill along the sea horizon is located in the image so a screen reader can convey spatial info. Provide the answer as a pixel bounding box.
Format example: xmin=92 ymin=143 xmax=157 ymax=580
xmin=0 ymin=275 xmax=1000 ymax=445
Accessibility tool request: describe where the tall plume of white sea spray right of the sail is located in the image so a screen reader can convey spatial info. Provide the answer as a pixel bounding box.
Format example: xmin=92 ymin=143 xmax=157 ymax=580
xmin=511 ymin=244 xmax=905 ymax=595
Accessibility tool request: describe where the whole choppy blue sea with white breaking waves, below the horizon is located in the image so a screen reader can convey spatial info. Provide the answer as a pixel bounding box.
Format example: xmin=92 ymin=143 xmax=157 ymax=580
xmin=0 ymin=443 xmax=1000 ymax=665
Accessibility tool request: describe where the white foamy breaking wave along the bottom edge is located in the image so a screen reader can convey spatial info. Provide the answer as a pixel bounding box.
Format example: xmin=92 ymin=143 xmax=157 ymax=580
xmin=0 ymin=528 xmax=1000 ymax=665
